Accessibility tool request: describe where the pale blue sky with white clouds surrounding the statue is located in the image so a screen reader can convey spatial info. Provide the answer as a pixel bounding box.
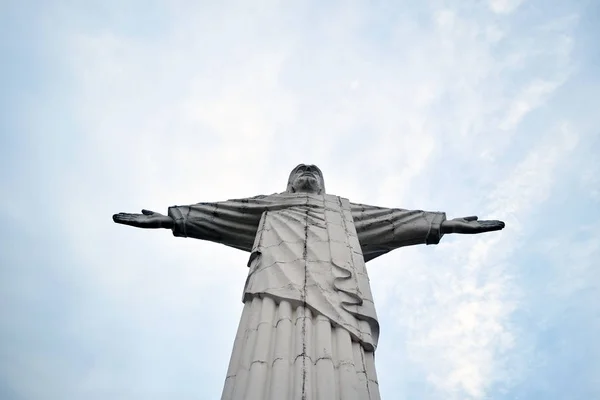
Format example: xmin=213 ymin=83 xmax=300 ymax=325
xmin=0 ymin=0 xmax=600 ymax=400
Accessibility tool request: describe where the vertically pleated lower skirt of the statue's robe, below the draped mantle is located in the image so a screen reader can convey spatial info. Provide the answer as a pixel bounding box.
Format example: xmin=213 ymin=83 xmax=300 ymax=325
xmin=221 ymin=295 xmax=380 ymax=400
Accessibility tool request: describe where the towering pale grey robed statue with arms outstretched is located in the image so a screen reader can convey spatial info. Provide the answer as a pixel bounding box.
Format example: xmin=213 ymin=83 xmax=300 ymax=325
xmin=113 ymin=164 xmax=504 ymax=400
